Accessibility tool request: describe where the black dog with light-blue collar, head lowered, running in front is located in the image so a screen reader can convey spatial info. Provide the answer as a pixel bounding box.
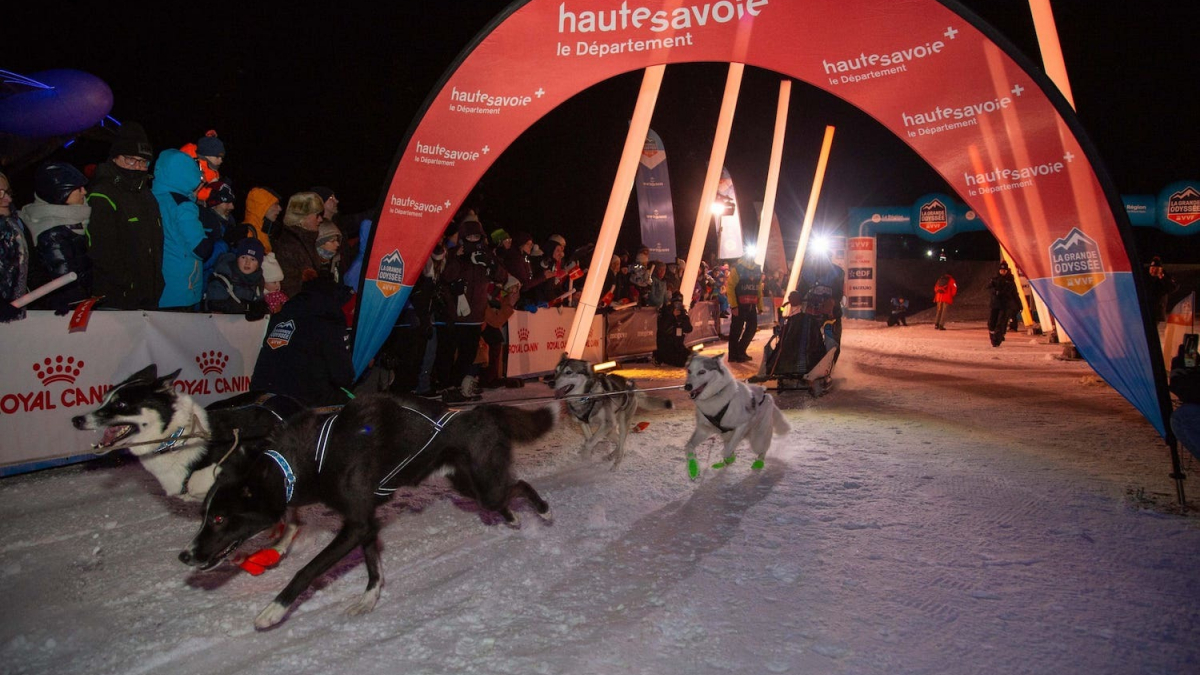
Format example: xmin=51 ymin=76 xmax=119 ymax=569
xmin=179 ymin=394 xmax=556 ymax=628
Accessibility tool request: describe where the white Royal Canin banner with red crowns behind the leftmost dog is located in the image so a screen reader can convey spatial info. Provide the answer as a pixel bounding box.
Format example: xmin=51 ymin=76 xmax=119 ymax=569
xmin=0 ymin=311 xmax=266 ymax=472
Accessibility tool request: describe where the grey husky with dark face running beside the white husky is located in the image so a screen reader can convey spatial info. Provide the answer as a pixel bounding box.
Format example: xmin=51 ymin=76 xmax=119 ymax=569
xmin=552 ymin=354 xmax=673 ymax=470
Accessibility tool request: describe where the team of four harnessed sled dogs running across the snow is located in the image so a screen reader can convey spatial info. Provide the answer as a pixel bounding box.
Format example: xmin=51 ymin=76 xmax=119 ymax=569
xmin=72 ymin=354 xmax=790 ymax=629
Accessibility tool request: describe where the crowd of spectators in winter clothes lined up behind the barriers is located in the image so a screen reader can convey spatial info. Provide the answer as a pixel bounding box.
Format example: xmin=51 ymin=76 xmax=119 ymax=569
xmin=0 ymin=121 xmax=782 ymax=401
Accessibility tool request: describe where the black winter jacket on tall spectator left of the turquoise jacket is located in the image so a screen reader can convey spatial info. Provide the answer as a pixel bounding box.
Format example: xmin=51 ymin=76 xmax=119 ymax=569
xmin=88 ymin=161 xmax=163 ymax=310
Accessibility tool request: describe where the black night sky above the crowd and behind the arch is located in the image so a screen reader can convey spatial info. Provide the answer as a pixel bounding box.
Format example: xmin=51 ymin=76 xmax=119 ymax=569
xmin=11 ymin=0 xmax=1200 ymax=263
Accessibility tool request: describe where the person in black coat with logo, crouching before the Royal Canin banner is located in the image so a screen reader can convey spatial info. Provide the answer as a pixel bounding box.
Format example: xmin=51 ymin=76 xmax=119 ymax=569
xmin=250 ymin=276 xmax=354 ymax=406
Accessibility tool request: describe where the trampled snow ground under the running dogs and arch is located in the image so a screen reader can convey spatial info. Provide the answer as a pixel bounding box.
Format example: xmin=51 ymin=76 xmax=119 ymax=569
xmin=0 ymin=322 xmax=1200 ymax=675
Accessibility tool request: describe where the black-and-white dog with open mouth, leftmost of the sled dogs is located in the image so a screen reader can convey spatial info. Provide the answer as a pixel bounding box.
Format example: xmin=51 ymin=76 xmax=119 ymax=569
xmin=71 ymin=364 xmax=304 ymax=501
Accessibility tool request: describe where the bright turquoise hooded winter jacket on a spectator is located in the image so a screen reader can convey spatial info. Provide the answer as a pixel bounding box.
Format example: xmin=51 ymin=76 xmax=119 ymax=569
xmin=150 ymin=150 xmax=206 ymax=307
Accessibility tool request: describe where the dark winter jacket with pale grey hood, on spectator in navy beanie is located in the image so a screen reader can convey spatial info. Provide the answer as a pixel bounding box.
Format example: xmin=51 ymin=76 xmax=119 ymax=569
xmin=20 ymin=197 xmax=92 ymax=310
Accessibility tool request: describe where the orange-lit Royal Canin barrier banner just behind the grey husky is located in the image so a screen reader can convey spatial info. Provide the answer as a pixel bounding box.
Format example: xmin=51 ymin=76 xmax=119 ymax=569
xmin=509 ymin=307 xmax=605 ymax=377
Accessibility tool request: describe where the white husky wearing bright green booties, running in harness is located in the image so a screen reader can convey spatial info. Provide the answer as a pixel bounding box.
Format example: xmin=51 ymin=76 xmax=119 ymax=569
xmin=683 ymin=354 xmax=791 ymax=480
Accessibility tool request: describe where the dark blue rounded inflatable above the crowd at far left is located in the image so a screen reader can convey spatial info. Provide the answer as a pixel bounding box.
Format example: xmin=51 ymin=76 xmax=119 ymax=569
xmin=0 ymin=70 xmax=113 ymax=138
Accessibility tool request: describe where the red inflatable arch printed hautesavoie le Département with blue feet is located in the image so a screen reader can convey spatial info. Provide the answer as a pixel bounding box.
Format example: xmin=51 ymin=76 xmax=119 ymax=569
xmin=354 ymin=0 xmax=1161 ymax=436
